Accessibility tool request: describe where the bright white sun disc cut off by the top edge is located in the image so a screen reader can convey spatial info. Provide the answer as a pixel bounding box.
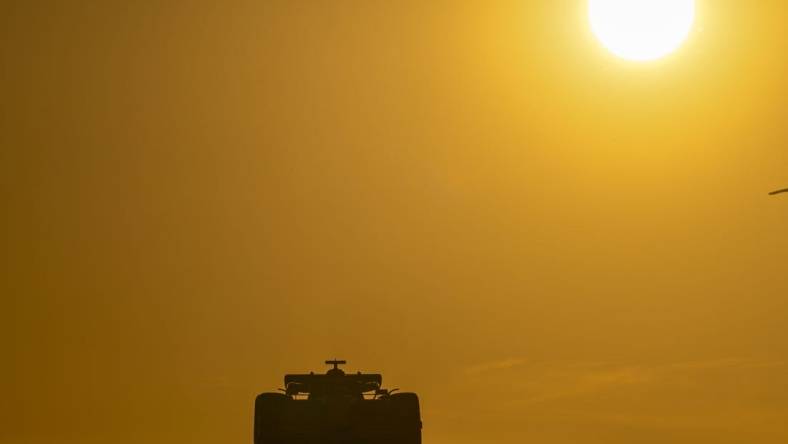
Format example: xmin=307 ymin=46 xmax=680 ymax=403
xmin=588 ymin=0 xmax=695 ymax=61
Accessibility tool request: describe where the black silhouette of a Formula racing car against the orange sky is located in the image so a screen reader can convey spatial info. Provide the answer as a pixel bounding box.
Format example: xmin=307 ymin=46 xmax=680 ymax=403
xmin=254 ymin=360 xmax=421 ymax=444
